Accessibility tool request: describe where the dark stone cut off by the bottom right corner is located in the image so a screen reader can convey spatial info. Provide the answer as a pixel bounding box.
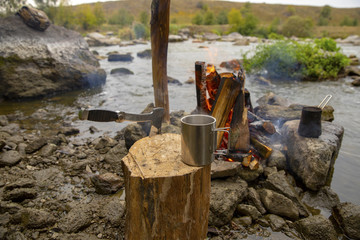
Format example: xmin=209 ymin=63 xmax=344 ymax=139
xmin=332 ymin=202 xmax=360 ymax=239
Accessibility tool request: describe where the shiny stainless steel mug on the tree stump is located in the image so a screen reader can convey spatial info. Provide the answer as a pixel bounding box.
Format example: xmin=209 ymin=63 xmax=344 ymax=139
xmin=181 ymin=114 xmax=229 ymax=166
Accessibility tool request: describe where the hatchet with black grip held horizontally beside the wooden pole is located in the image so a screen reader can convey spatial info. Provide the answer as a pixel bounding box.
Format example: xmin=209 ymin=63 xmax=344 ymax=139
xmin=79 ymin=107 xmax=164 ymax=133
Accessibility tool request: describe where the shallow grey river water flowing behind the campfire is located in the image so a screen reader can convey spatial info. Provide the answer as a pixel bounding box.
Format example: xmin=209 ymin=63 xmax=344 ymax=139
xmin=0 ymin=41 xmax=360 ymax=204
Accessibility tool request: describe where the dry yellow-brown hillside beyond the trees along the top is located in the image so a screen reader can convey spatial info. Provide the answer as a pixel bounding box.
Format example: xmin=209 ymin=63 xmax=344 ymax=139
xmin=88 ymin=0 xmax=360 ymax=25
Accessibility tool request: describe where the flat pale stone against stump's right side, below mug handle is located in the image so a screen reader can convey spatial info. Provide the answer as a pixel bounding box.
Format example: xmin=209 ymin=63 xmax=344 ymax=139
xmin=211 ymin=160 xmax=241 ymax=179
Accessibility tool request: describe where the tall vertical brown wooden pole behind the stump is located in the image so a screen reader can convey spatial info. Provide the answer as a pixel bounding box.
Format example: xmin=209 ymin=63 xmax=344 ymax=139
xmin=150 ymin=0 xmax=170 ymax=122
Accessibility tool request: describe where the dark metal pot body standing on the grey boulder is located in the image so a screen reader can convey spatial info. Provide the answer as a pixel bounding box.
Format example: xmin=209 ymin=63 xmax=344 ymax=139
xmin=298 ymin=107 xmax=322 ymax=138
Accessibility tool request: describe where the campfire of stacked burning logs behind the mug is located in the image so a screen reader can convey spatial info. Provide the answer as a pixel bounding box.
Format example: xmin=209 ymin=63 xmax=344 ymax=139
xmin=195 ymin=62 xmax=278 ymax=170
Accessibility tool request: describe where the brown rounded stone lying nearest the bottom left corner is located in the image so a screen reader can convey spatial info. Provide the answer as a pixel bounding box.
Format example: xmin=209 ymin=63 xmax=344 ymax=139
xmin=21 ymin=208 xmax=56 ymax=228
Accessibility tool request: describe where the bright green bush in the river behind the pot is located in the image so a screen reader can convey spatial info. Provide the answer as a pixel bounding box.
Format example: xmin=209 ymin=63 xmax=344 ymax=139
xmin=243 ymin=39 xmax=349 ymax=80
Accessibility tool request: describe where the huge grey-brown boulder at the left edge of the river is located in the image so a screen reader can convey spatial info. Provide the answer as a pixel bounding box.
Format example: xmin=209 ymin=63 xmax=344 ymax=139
xmin=0 ymin=16 xmax=106 ymax=99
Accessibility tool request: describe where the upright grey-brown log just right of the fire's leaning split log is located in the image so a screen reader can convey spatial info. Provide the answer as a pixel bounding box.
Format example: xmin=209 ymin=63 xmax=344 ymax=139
xmin=230 ymin=70 xmax=250 ymax=151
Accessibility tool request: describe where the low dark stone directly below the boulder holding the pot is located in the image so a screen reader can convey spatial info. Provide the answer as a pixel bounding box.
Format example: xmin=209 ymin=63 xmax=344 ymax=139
xmin=301 ymin=186 xmax=340 ymax=211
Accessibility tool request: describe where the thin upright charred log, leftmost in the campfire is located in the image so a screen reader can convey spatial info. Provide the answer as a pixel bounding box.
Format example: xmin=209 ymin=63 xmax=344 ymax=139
xmin=195 ymin=61 xmax=209 ymax=113
